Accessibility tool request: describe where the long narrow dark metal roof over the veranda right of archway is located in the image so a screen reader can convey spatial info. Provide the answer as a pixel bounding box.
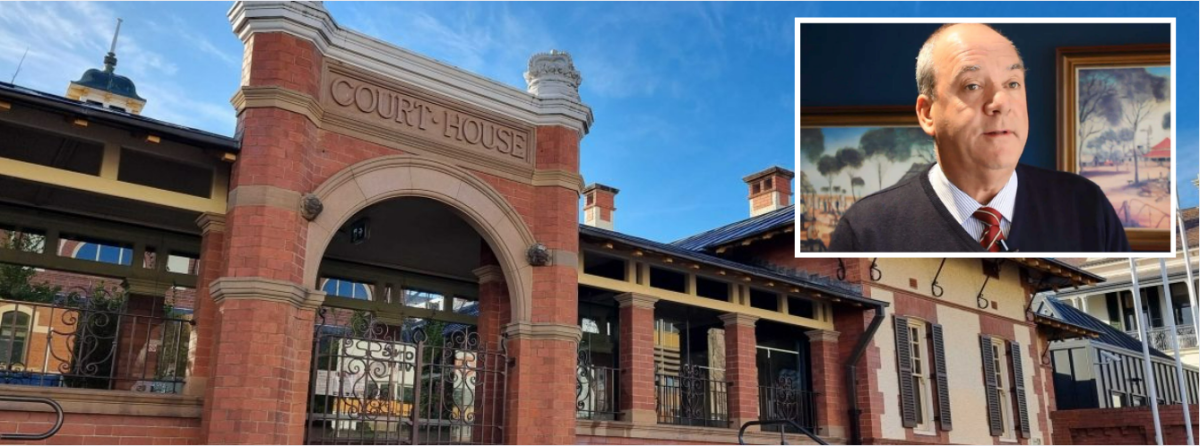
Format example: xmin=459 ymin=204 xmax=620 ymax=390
xmin=580 ymin=224 xmax=888 ymax=307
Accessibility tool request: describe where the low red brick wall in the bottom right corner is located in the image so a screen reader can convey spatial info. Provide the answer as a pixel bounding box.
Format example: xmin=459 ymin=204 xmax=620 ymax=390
xmin=1050 ymin=404 xmax=1200 ymax=445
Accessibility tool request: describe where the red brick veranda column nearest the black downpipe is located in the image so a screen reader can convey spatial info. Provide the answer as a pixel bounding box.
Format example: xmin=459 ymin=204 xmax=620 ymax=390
xmin=804 ymin=330 xmax=846 ymax=439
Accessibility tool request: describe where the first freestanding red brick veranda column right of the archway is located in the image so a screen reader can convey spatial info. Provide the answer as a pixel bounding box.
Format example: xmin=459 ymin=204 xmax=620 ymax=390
xmin=617 ymin=293 xmax=659 ymax=424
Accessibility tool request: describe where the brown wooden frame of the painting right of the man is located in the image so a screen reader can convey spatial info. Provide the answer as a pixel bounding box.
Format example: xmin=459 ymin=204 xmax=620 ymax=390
xmin=1055 ymin=43 xmax=1175 ymax=252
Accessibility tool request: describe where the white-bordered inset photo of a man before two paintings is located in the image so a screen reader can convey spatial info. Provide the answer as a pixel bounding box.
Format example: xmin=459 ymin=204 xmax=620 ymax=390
xmin=796 ymin=19 xmax=1176 ymax=257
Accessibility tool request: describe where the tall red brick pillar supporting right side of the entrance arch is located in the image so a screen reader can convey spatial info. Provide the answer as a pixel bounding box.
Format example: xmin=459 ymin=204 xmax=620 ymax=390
xmin=505 ymin=126 xmax=582 ymax=445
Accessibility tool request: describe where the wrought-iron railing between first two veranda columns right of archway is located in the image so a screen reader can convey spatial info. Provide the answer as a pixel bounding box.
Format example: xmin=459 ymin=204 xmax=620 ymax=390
xmin=654 ymin=366 xmax=731 ymax=428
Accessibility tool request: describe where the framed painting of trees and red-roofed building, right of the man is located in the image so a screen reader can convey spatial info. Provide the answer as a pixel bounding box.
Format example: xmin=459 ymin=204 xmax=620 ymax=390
xmin=1056 ymin=44 xmax=1174 ymax=252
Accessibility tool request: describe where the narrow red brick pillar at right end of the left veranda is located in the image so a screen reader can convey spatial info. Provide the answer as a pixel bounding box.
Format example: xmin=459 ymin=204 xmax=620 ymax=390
xmin=184 ymin=213 xmax=226 ymax=400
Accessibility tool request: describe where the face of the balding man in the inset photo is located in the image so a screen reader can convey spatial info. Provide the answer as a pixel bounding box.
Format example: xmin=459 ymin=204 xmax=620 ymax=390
xmin=925 ymin=24 xmax=1030 ymax=173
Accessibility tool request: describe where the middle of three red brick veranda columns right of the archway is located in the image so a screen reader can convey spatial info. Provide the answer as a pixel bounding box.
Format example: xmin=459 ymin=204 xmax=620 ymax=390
xmin=720 ymin=313 xmax=758 ymax=428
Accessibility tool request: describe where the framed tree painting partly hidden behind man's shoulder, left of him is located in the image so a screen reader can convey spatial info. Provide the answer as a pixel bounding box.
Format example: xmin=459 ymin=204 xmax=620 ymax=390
xmin=796 ymin=106 xmax=936 ymax=252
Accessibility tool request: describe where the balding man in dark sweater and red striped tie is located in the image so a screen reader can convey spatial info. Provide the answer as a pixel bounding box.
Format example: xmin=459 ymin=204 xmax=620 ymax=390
xmin=829 ymin=24 xmax=1130 ymax=253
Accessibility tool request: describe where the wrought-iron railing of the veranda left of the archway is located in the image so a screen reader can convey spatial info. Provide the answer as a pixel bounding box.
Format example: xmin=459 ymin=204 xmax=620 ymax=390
xmin=0 ymin=296 xmax=194 ymax=393
